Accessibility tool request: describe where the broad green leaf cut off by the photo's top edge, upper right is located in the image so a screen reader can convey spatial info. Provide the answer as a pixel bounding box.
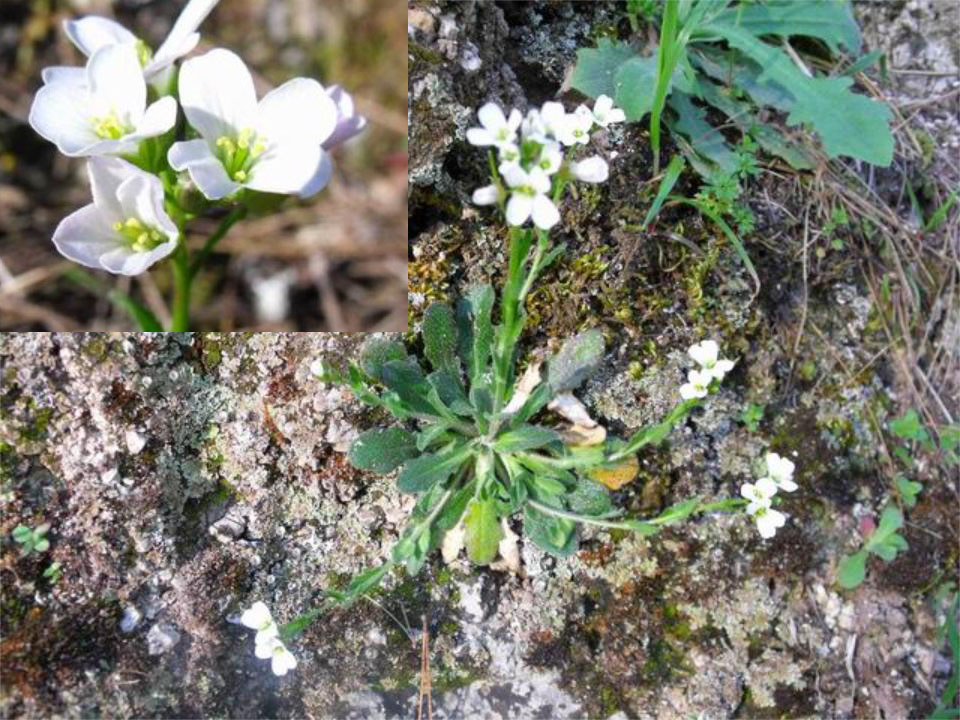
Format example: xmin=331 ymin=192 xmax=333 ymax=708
xmin=713 ymin=0 xmax=860 ymax=53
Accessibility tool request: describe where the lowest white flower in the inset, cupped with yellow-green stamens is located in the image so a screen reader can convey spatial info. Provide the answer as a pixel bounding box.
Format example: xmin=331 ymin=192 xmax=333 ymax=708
xmin=53 ymin=157 xmax=180 ymax=275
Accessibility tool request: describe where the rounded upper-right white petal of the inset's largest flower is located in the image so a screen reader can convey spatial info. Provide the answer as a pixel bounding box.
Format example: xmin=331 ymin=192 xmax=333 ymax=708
xmin=254 ymin=78 xmax=338 ymax=145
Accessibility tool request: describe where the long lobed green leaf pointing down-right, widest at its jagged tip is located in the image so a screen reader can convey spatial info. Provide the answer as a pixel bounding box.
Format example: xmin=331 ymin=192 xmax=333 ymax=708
xmin=708 ymin=23 xmax=893 ymax=167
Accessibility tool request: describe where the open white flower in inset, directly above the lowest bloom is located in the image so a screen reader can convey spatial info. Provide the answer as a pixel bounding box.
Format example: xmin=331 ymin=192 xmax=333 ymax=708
xmin=29 ymin=45 xmax=177 ymax=157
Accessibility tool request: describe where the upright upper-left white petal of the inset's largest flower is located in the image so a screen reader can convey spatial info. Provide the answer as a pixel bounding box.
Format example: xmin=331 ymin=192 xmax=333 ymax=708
xmin=179 ymin=49 xmax=257 ymax=141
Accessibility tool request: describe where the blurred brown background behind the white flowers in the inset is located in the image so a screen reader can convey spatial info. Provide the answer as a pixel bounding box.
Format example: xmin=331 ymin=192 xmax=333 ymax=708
xmin=0 ymin=0 xmax=407 ymax=332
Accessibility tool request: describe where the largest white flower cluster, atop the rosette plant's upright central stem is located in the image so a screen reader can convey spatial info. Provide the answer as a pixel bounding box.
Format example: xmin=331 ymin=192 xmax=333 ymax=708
xmin=467 ymin=95 xmax=625 ymax=230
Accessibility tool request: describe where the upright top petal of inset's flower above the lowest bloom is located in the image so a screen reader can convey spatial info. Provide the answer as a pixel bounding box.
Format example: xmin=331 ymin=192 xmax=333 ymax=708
xmin=87 ymin=44 xmax=147 ymax=126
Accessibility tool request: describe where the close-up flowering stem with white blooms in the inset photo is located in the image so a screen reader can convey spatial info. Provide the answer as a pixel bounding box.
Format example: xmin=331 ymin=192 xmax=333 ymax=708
xmin=29 ymin=0 xmax=365 ymax=331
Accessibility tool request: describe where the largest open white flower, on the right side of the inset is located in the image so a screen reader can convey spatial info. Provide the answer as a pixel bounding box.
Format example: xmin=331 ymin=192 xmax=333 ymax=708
xmin=167 ymin=49 xmax=339 ymax=200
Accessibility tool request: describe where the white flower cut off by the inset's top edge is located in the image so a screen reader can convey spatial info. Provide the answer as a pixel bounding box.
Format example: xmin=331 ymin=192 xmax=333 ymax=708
xmin=43 ymin=0 xmax=219 ymax=83
